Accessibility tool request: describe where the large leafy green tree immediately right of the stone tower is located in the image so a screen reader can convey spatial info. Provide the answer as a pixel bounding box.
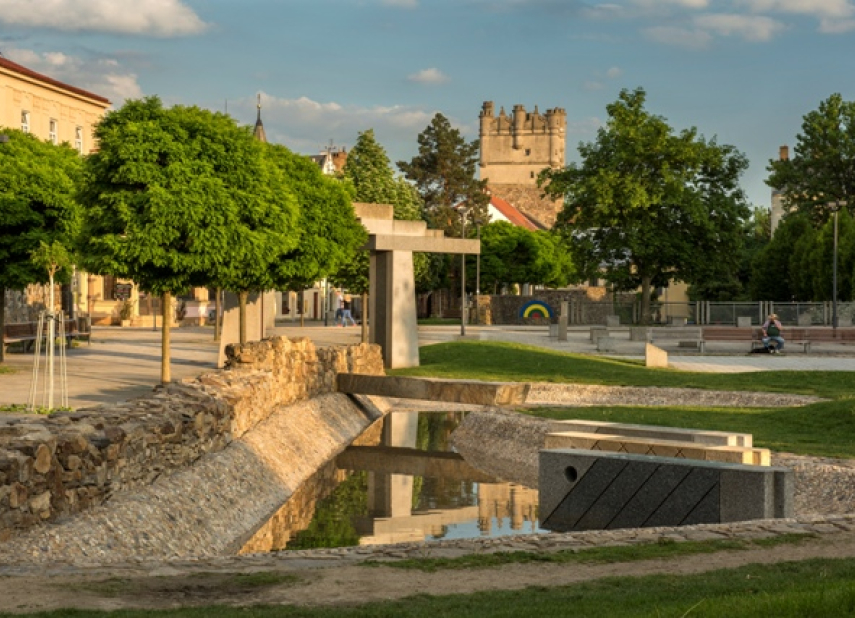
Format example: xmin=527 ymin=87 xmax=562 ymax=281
xmin=540 ymin=88 xmax=749 ymax=322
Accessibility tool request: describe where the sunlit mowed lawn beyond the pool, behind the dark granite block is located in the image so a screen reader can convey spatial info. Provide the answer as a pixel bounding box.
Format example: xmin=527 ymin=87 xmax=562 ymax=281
xmin=390 ymin=341 xmax=855 ymax=459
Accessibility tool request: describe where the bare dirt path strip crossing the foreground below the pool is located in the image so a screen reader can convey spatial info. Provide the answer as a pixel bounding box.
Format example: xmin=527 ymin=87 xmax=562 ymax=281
xmin=5 ymin=531 xmax=855 ymax=613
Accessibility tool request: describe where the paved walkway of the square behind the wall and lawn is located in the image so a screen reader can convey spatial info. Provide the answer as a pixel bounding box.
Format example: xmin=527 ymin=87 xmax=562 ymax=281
xmin=0 ymin=323 xmax=855 ymax=409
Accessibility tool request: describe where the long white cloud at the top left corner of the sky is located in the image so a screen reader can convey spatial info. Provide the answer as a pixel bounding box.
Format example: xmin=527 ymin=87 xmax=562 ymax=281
xmin=0 ymin=0 xmax=208 ymax=37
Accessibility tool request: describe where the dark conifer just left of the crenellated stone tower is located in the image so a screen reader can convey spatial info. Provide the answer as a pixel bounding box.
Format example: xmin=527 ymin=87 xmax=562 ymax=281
xmin=398 ymin=114 xmax=490 ymax=237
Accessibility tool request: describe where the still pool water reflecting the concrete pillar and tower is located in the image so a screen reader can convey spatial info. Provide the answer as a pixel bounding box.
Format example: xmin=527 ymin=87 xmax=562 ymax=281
xmin=241 ymin=412 xmax=541 ymax=553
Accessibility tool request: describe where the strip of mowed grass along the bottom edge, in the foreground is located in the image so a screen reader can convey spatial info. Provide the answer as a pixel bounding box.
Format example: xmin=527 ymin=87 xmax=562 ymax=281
xmin=3 ymin=559 xmax=855 ymax=618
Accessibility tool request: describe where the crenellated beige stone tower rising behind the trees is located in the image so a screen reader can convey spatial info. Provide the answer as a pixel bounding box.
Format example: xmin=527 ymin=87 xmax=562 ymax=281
xmin=479 ymin=101 xmax=567 ymax=228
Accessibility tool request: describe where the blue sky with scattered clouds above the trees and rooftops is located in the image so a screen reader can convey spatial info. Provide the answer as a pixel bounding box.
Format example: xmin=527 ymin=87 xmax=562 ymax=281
xmin=0 ymin=0 xmax=855 ymax=207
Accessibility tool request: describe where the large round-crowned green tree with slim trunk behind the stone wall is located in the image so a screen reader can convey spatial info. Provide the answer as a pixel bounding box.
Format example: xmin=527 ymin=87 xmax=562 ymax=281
xmin=81 ymin=97 xmax=297 ymax=382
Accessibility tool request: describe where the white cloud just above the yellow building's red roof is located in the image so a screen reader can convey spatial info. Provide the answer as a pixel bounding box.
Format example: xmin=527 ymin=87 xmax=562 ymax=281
xmin=0 ymin=41 xmax=143 ymax=107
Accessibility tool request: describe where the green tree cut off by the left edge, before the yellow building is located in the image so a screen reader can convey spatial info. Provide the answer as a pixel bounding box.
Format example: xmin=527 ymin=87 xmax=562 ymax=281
xmin=0 ymin=129 xmax=81 ymax=362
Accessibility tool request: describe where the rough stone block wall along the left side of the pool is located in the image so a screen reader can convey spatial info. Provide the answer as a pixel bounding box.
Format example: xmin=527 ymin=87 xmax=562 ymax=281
xmin=0 ymin=338 xmax=384 ymax=541
